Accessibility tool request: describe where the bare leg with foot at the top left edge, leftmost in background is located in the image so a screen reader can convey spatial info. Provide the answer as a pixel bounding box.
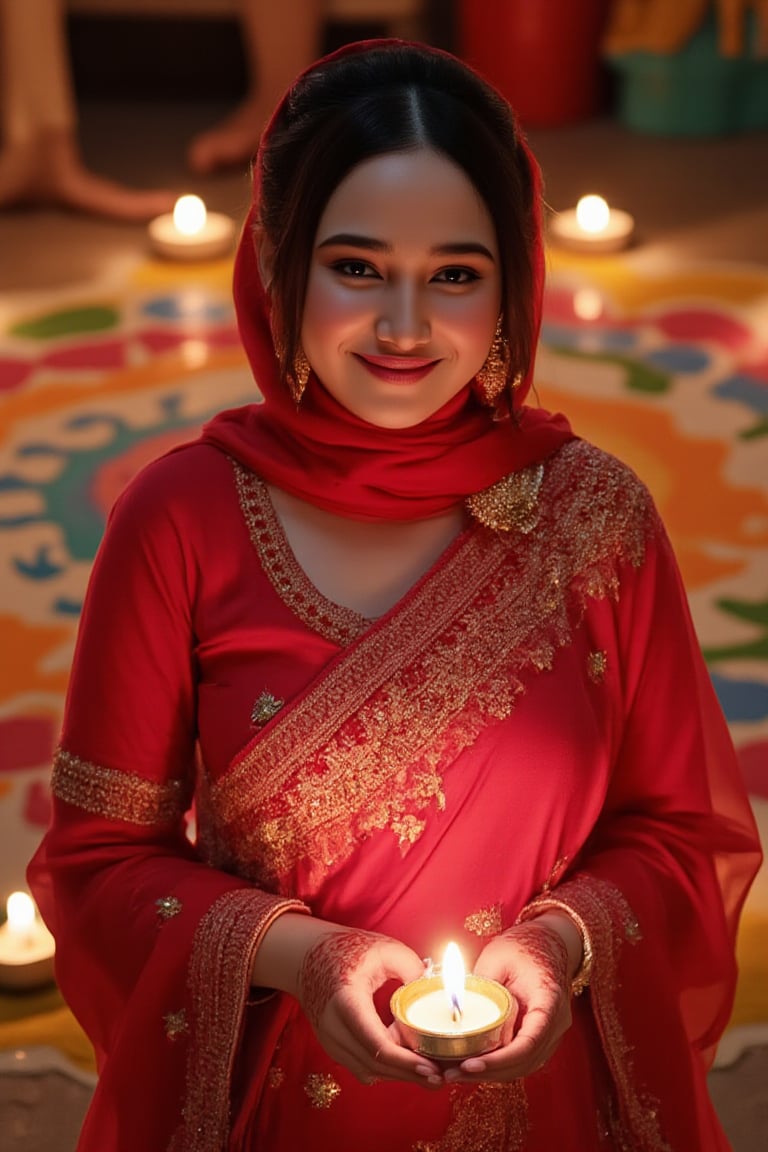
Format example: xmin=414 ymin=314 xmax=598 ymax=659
xmin=0 ymin=0 xmax=174 ymax=220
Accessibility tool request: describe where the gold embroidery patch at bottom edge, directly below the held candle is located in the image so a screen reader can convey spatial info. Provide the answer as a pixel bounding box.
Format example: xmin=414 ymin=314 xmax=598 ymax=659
xmin=435 ymin=1081 xmax=529 ymax=1152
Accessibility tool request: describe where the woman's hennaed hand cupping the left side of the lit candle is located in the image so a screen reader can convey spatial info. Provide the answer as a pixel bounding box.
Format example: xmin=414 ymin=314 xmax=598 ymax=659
xmin=298 ymin=929 xmax=442 ymax=1087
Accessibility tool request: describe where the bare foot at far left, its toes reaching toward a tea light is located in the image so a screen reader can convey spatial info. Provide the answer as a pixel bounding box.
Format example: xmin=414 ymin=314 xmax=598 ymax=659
xmin=0 ymin=132 xmax=176 ymax=221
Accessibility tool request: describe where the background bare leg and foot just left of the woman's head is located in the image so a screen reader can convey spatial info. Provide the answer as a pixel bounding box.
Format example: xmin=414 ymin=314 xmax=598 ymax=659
xmin=188 ymin=0 xmax=322 ymax=173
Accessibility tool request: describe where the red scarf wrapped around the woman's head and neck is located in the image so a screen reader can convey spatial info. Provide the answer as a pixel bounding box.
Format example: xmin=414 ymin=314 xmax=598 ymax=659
xmin=203 ymin=40 xmax=572 ymax=521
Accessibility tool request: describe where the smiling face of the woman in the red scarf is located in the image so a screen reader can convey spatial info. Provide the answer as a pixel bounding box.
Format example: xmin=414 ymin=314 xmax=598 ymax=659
xmin=302 ymin=149 xmax=501 ymax=429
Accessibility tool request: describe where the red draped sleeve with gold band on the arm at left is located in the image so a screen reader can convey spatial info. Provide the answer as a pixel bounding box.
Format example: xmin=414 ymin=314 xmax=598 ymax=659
xmin=29 ymin=449 xmax=305 ymax=1152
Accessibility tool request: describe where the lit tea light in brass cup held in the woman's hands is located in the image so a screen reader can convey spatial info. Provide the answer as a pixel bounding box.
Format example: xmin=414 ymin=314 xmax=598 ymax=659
xmin=390 ymin=943 xmax=512 ymax=1060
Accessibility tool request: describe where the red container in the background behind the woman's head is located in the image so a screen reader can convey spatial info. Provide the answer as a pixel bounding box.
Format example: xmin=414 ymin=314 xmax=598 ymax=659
xmin=458 ymin=0 xmax=610 ymax=127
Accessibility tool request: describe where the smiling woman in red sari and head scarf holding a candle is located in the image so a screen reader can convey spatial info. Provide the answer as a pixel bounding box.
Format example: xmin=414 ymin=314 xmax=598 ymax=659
xmin=30 ymin=41 xmax=759 ymax=1152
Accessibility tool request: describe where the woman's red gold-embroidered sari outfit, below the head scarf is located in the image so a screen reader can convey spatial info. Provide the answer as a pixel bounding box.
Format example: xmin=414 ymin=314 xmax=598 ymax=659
xmin=30 ymin=441 xmax=758 ymax=1152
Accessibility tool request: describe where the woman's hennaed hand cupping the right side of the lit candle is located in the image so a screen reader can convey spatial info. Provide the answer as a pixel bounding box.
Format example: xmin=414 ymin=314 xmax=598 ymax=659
xmin=444 ymin=912 xmax=581 ymax=1084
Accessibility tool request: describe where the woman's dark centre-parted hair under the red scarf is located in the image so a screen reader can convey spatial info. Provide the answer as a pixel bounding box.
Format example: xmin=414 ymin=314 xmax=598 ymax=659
xmin=258 ymin=44 xmax=539 ymax=396
